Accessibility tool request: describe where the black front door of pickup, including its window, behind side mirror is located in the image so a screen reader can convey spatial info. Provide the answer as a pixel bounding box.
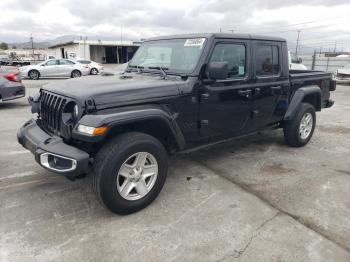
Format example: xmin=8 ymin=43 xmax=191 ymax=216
xmin=199 ymin=39 xmax=252 ymax=137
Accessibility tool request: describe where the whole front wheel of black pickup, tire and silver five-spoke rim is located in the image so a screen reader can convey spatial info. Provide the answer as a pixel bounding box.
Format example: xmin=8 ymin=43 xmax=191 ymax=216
xmin=94 ymin=132 xmax=168 ymax=215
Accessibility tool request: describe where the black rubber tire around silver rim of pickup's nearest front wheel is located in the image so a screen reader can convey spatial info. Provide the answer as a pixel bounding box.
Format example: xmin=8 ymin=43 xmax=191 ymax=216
xmin=93 ymin=132 xmax=168 ymax=215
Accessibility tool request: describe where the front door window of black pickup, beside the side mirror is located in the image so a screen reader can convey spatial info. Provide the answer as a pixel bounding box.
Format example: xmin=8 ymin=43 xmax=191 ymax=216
xmin=210 ymin=43 xmax=246 ymax=78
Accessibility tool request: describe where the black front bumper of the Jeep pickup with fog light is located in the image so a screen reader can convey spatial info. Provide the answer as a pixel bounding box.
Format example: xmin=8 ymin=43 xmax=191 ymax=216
xmin=17 ymin=119 xmax=90 ymax=177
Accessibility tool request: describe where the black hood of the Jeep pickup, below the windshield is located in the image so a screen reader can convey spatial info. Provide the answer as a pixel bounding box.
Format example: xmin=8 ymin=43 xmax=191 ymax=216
xmin=43 ymin=74 xmax=183 ymax=109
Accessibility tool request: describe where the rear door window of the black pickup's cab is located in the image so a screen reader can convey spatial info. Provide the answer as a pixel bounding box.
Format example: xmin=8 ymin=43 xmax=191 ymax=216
xmin=255 ymin=45 xmax=280 ymax=76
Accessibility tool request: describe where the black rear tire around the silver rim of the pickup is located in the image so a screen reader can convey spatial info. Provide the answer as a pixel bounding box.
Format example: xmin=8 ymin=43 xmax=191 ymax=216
xmin=283 ymin=103 xmax=316 ymax=147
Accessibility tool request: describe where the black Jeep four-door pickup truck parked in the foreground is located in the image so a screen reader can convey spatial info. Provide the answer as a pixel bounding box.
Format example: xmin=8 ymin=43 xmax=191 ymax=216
xmin=17 ymin=33 xmax=336 ymax=214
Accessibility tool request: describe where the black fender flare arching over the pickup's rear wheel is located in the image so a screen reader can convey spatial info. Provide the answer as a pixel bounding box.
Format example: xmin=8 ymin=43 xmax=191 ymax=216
xmin=283 ymin=85 xmax=321 ymax=121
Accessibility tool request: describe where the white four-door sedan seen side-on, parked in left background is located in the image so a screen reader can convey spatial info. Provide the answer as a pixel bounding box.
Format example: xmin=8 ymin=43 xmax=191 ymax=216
xmin=19 ymin=59 xmax=90 ymax=80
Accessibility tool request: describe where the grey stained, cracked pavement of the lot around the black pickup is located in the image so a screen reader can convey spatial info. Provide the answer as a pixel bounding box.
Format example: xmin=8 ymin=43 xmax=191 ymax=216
xmin=0 ymin=76 xmax=350 ymax=262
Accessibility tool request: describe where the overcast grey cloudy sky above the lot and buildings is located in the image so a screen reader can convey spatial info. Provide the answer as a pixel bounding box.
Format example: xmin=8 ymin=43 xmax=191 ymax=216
xmin=0 ymin=0 xmax=350 ymax=51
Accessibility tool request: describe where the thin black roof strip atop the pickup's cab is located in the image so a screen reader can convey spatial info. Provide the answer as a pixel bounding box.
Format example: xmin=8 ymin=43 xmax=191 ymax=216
xmin=145 ymin=33 xmax=286 ymax=42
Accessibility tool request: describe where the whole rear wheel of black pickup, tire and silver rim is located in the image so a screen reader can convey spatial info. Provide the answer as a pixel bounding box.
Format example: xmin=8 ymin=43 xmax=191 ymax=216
xmin=283 ymin=103 xmax=316 ymax=147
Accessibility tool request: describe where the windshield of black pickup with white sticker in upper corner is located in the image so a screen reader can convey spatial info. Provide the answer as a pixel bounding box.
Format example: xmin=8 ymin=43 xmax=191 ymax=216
xmin=129 ymin=38 xmax=205 ymax=73
